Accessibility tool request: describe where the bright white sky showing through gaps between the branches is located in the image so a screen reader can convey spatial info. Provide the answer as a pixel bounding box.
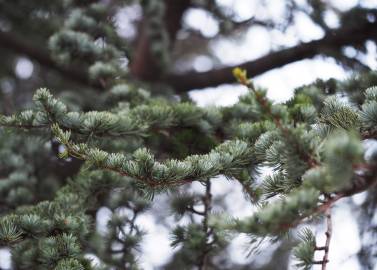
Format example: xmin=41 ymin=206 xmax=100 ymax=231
xmin=0 ymin=0 xmax=377 ymax=270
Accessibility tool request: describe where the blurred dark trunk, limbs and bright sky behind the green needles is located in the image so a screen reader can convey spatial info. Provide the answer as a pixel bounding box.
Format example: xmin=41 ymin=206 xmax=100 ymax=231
xmin=0 ymin=0 xmax=377 ymax=270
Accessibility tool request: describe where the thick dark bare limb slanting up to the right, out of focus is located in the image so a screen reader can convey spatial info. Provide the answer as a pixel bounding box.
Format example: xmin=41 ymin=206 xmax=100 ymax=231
xmin=164 ymin=19 xmax=377 ymax=93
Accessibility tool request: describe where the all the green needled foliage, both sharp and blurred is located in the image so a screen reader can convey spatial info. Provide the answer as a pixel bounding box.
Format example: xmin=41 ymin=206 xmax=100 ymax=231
xmin=0 ymin=0 xmax=377 ymax=270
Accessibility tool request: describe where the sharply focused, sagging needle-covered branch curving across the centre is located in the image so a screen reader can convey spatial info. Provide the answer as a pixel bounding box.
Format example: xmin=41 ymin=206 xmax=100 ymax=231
xmin=52 ymin=124 xmax=252 ymax=188
